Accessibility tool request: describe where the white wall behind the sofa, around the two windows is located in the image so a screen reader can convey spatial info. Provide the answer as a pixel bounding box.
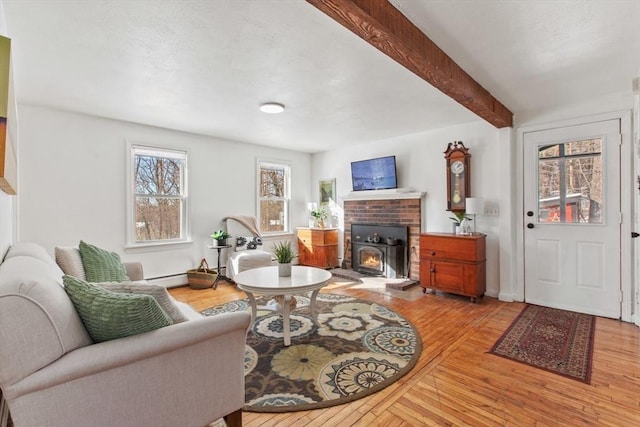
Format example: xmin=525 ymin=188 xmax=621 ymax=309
xmin=18 ymin=104 xmax=311 ymax=277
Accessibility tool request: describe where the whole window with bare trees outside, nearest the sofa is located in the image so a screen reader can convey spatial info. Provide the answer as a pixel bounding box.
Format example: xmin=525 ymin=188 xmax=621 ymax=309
xmin=128 ymin=145 xmax=187 ymax=244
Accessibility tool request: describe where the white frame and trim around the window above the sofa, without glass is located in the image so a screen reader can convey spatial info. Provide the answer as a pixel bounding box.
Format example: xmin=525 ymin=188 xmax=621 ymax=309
xmin=126 ymin=142 xmax=192 ymax=249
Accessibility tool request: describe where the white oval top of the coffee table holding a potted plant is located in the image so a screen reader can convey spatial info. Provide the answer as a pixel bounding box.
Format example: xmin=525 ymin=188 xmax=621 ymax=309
xmin=234 ymin=265 xmax=331 ymax=295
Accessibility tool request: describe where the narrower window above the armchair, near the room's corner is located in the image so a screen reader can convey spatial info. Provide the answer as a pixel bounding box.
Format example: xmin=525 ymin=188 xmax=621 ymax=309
xmin=257 ymin=160 xmax=291 ymax=234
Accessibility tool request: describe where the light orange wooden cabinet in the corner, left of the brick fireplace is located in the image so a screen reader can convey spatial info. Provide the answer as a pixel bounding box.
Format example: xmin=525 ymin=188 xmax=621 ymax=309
xmin=298 ymin=227 xmax=338 ymax=268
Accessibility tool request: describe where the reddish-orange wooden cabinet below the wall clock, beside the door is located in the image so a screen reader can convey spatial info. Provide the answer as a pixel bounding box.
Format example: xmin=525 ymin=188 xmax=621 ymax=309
xmin=420 ymin=233 xmax=487 ymax=302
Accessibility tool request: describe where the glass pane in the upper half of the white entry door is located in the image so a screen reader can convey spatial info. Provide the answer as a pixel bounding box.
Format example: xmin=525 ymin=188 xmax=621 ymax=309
xmin=538 ymin=138 xmax=604 ymax=224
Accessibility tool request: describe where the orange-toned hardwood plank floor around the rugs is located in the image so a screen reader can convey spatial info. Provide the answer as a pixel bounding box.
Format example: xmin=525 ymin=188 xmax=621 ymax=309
xmin=170 ymin=283 xmax=640 ymax=427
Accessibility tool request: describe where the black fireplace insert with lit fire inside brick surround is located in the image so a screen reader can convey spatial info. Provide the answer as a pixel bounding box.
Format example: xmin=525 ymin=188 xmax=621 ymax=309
xmin=351 ymin=223 xmax=408 ymax=279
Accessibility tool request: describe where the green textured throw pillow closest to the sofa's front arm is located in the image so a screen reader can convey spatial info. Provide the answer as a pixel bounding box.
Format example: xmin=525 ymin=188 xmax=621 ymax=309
xmin=62 ymin=275 xmax=173 ymax=343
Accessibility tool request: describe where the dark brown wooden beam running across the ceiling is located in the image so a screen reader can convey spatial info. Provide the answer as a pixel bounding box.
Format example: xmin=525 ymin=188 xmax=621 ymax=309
xmin=307 ymin=0 xmax=513 ymax=128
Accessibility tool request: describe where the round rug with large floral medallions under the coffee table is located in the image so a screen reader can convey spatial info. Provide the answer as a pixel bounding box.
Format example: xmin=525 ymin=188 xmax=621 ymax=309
xmin=202 ymin=293 xmax=422 ymax=412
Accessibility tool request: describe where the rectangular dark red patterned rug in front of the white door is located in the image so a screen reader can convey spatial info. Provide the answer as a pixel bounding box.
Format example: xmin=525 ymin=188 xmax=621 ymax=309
xmin=489 ymin=305 xmax=596 ymax=384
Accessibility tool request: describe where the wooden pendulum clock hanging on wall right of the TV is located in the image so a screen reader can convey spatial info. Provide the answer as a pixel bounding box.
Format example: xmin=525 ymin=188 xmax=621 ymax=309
xmin=444 ymin=141 xmax=471 ymax=212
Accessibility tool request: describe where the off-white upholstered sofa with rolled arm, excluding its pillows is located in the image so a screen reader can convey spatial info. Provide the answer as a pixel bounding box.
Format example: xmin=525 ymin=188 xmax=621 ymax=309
xmin=0 ymin=243 xmax=250 ymax=427
